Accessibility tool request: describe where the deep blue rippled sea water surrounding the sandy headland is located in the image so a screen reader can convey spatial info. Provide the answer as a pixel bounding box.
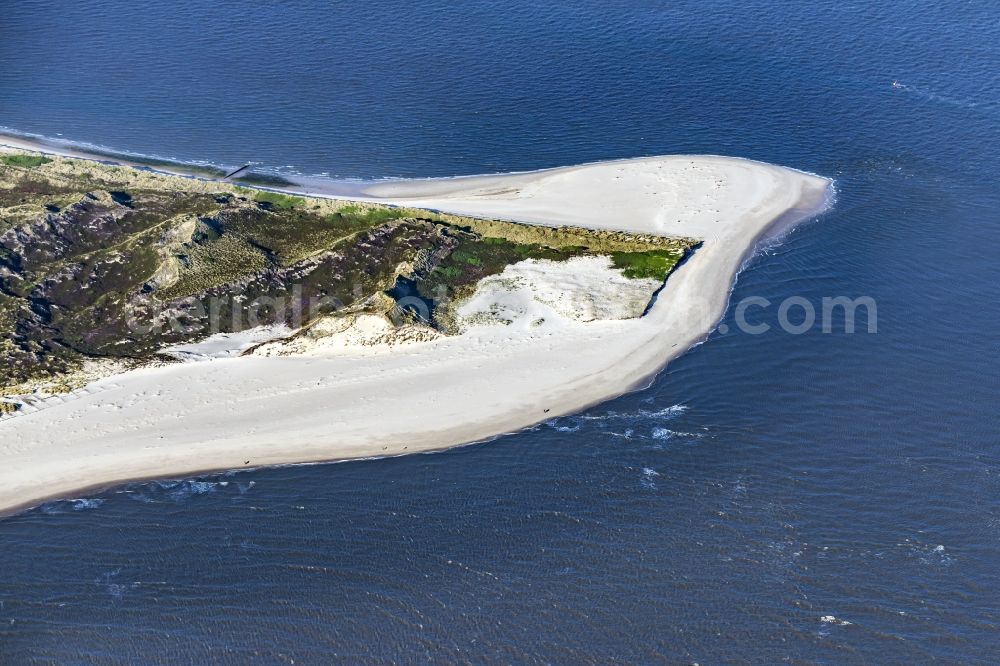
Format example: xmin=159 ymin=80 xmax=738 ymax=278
xmin=0 ymin=0 xmax=1000 ymax=664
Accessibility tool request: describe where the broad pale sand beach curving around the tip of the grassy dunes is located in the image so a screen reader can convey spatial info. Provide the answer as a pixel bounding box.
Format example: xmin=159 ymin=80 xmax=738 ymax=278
xmin=0 ymin=137 xmax=832 ymax=515
